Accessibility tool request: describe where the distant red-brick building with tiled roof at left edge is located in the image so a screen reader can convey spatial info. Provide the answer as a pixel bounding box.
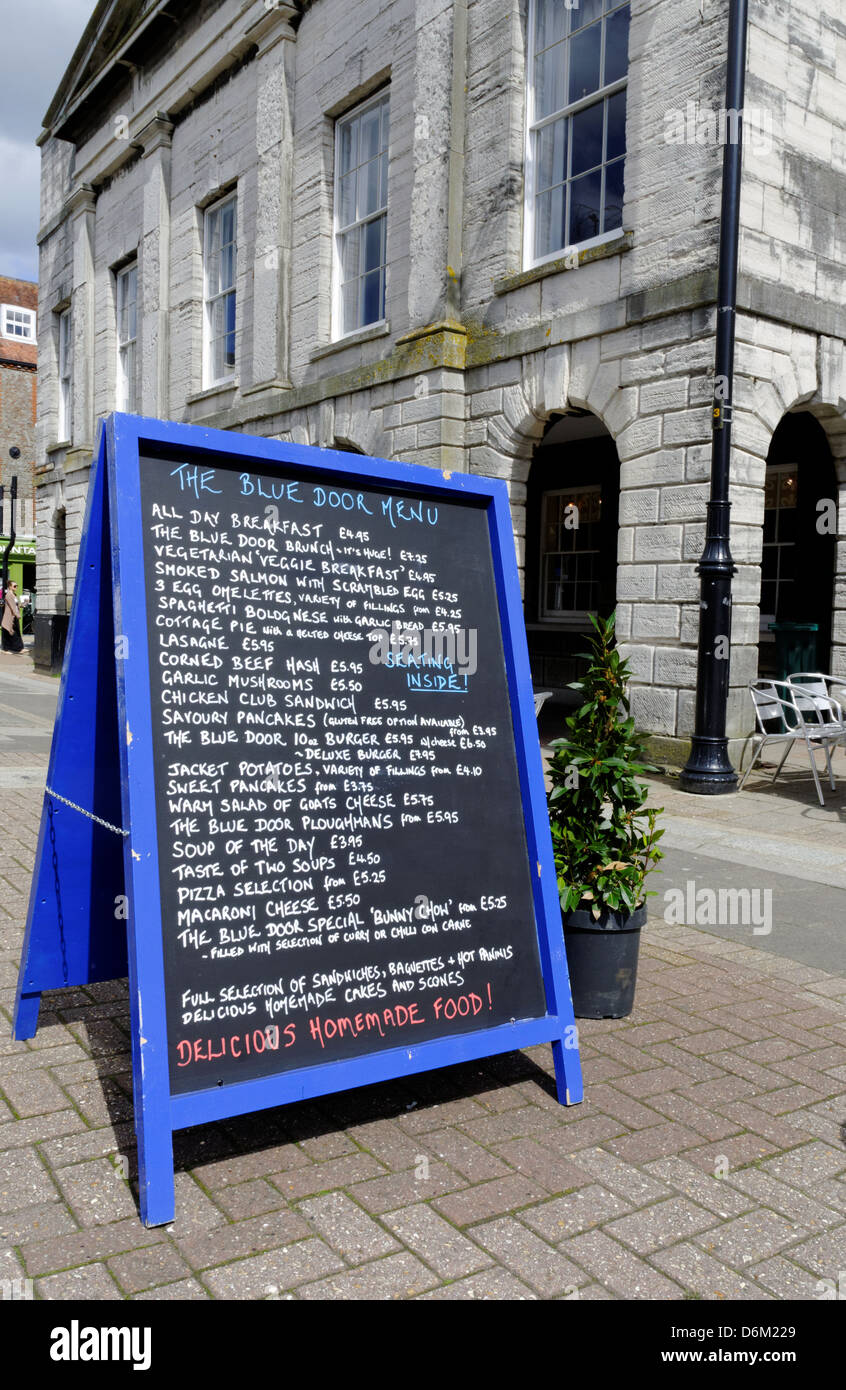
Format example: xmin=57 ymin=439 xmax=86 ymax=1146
xmin=0 ymin=275 xmax=38 ymax=594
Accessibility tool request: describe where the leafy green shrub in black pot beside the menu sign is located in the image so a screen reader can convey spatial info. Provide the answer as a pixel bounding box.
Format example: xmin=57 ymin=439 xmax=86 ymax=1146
xmin=549 ymin=614 xmax=664 ymax=1019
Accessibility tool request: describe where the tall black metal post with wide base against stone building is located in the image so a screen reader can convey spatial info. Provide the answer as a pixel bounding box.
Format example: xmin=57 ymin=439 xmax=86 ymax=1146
xmin=681 ymin=0 xmax=747 ymax=796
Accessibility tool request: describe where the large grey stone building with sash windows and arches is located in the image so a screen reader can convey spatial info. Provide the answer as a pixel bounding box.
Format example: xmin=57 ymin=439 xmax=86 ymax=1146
xmin=38 ymin=0 xmax=846 ymax=761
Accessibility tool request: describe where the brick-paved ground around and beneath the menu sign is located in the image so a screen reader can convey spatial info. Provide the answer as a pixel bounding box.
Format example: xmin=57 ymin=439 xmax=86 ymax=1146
xmin=0 ymin=657 xmax=846 ymax=1301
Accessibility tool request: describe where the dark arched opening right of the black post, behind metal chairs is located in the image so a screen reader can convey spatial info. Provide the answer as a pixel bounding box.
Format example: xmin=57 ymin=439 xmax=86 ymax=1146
xmin=758 ymin=410 xmax=838 ymax=676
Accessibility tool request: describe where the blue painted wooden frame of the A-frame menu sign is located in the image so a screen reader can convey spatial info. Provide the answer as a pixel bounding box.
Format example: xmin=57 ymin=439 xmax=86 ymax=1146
xmin=14 ymin=414 xmax=582 ymax=1226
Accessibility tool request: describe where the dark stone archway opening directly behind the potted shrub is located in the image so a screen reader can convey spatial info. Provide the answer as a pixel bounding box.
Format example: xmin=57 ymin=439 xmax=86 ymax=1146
xmin=524 ymin=410 xmax=620 ymax=703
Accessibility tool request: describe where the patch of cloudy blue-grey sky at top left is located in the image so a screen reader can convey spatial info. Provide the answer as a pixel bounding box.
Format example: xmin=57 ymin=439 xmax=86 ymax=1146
xmin=0 ymin=0 xmax=96 ymax=279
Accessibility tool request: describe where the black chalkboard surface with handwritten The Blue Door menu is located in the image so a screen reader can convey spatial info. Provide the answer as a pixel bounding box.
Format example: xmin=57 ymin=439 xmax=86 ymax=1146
xmin=140 ymin=455 xmax=546 ymax=1094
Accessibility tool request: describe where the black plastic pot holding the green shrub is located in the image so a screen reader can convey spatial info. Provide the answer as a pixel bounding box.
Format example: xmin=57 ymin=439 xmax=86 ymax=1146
xmin=561 ymin=902 xmax=646 ymax=1019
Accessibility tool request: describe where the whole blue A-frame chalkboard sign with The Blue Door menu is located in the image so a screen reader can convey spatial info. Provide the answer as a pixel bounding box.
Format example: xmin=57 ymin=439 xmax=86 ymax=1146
xmin=14 ymin=414 xmax=582 ymax=1226
